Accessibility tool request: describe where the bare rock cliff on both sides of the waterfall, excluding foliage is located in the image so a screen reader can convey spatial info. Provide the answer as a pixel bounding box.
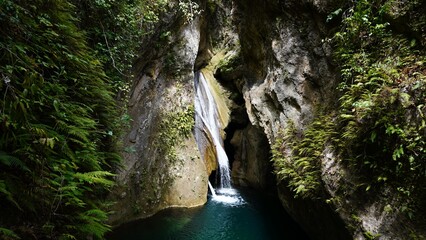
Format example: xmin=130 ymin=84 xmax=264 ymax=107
xmin=113 ymin=0 xmax=424 ymax=239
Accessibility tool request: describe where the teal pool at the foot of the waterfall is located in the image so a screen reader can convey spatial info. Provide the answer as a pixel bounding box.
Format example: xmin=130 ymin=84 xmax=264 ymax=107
xmin=107 ymin=189 xmax=309 ymax=240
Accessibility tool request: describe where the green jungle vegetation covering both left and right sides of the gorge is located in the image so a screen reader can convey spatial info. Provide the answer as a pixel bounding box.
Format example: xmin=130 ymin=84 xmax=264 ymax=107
xmin=0 ymin=0 xmax=426 ymax=239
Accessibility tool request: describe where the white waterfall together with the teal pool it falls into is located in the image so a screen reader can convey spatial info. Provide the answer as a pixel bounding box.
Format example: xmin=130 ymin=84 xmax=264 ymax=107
xmin=107 ymin=73 xmax=308 ymax=240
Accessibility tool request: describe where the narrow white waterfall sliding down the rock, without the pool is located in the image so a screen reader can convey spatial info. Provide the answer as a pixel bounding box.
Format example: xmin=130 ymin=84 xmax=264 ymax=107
xmin=195 ymin=72 xmax=231 ymax=189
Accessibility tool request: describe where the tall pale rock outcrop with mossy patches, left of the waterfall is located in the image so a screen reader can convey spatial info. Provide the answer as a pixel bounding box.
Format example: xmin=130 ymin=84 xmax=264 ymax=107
xmin=110 ymin=13 xmax=208 ymax=225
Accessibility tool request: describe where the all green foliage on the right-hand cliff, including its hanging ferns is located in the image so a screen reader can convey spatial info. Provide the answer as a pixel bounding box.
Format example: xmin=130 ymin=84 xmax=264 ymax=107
xmin=272 ymin=0 xmax=426 ymax=219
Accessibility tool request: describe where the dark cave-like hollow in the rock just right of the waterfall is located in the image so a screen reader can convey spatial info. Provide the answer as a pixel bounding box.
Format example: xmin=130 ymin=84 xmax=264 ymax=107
xmin=209 ymin=69 xmax=276 ymax=193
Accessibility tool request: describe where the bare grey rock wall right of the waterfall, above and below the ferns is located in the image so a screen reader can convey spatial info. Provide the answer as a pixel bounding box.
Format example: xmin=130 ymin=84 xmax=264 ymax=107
xmin=226 ymin=0 xmax=422 ymax=239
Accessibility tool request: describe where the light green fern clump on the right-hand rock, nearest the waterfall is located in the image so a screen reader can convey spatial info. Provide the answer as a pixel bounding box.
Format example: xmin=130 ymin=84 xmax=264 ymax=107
xmin=272 ymin=114 xmax=335 ymax=199
